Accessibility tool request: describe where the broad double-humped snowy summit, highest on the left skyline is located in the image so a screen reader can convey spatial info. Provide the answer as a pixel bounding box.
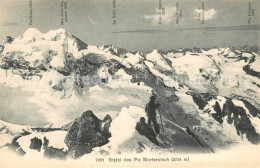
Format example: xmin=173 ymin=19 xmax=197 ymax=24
xmin=2 ymin=28 xmax=88 ymax=68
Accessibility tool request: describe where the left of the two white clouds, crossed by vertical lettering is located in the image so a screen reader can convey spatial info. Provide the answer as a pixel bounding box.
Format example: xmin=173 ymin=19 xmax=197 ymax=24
xmin=142 ymin=6 xmax=176 ymax=24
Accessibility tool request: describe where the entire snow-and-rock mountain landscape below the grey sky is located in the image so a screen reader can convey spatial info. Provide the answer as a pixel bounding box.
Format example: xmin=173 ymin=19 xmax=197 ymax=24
xmin=0 ymin=28 xmax=260 ymax=159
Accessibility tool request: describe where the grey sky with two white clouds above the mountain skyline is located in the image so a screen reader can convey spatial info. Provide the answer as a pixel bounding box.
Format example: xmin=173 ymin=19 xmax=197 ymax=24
xmin=0 ymin=0 xmax=260 ymax=52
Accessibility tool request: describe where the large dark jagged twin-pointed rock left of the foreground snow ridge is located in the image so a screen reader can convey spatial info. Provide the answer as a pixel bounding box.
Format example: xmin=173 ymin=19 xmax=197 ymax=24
xmin=65 ymin=110 xmax=112 ymax=158
